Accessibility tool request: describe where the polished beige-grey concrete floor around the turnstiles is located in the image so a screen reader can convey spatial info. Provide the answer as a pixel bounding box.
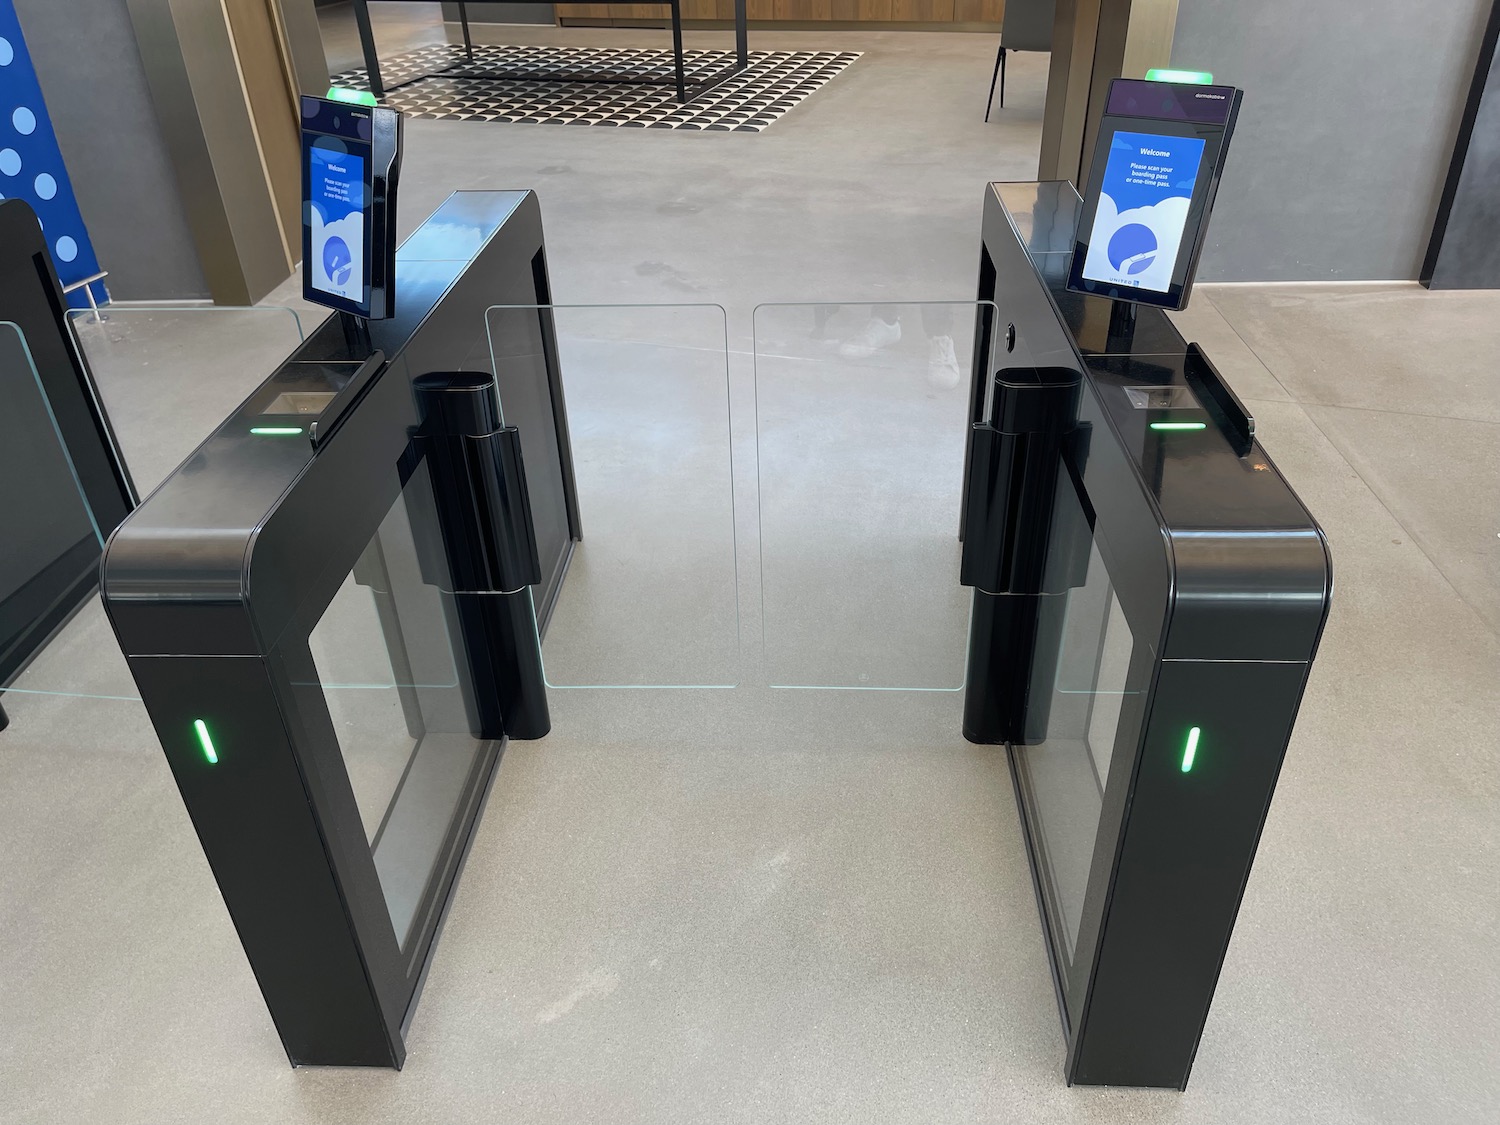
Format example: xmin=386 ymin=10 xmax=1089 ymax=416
xmin=0 ymin=5 xmax=1500 ymax=1125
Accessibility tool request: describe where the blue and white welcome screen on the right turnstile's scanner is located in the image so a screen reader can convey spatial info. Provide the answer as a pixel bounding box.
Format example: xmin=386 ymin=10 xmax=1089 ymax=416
xmin=1083 ymin=132 xmax=1203 ymax=293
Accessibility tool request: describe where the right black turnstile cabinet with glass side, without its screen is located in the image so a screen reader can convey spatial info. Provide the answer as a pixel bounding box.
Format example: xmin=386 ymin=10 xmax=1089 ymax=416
xmin=963 ymin=182 xmax=1332 ymax=1089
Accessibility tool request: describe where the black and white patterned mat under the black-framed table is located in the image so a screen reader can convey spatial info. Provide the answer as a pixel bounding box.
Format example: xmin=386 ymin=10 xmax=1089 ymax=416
xmin=333 ymin=44 xmax=861 ymax=132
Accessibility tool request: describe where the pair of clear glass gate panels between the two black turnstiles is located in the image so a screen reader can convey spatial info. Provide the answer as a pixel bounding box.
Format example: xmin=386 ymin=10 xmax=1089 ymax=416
xmin=486 ymin=302 xmax=980 ymax=693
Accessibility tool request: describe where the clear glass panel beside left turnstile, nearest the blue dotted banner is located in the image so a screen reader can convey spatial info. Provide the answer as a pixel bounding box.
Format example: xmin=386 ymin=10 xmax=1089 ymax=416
xmin=68 ymin=305 xmax=303 ymax=497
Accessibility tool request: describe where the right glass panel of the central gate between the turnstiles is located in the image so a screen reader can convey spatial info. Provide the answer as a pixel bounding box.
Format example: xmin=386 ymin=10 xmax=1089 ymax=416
xmin=755 ymin=302 xmax=993 ymax=692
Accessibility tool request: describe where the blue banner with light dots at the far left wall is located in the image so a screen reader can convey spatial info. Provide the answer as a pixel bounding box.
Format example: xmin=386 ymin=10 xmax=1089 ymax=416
xmin=0 ymin=0 xmax=108 ymax=306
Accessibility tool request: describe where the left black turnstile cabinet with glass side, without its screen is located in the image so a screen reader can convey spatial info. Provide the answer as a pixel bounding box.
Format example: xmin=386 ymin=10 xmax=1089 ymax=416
xmin=102 ymin=192 xmax=579 ymax=1067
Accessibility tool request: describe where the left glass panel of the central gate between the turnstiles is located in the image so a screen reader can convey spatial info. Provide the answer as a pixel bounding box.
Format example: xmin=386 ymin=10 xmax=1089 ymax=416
xmin=486 ymin=305 xmax=740 ymax=689
